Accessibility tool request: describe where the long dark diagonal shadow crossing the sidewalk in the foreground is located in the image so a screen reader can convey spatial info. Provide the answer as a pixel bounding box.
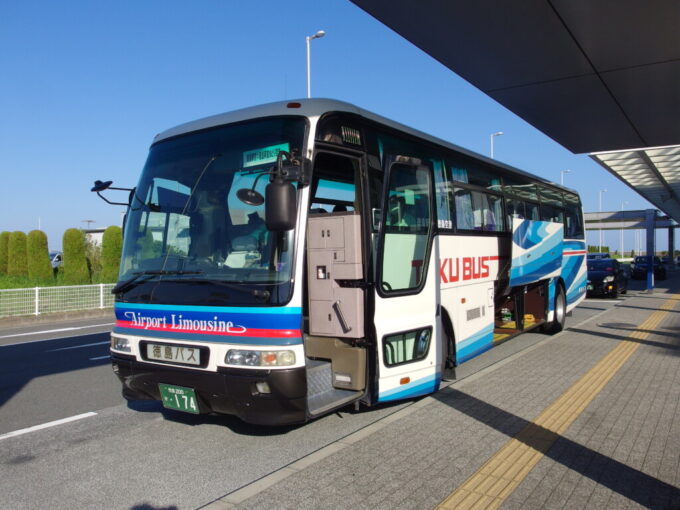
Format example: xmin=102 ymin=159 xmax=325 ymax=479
xmin=433 ymin=388 xmax=680 ymax=509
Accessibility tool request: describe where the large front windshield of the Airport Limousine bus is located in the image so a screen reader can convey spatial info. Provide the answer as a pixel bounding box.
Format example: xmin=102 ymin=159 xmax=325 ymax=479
xmin=119 ymin=117 xmax=306 ymax=296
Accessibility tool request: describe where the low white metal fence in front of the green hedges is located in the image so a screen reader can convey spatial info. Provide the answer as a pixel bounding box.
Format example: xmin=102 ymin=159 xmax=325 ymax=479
xmin=0 ymin=283 xmax=115 ymax=317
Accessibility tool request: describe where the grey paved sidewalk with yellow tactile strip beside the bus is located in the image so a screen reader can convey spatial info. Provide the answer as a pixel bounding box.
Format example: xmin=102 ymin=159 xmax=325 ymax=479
xmin=205 ymin=282 xmax=680 ymax=510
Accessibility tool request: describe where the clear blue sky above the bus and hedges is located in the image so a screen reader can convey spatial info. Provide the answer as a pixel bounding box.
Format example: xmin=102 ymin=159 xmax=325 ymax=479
xmin=0 ymin=0 xmax=666 ymax=251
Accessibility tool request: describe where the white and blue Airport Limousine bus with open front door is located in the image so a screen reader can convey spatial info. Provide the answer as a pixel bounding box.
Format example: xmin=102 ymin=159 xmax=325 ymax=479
xmin=103 ymin=99 xmax=586 ymax=425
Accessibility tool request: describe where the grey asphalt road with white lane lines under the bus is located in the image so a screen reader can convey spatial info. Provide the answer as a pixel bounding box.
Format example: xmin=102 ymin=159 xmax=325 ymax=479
xmin=0 ymin=278 xmax=660 ymax=510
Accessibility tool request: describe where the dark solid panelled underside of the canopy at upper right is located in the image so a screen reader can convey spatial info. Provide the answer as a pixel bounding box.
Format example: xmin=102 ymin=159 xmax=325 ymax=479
xmin=352 ymin=0 xmax=680 ymax=153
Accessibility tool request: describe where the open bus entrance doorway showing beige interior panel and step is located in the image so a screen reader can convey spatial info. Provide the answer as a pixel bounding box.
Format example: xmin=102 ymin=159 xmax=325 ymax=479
xmin=304 ymin=152 xmax=368 ymax=416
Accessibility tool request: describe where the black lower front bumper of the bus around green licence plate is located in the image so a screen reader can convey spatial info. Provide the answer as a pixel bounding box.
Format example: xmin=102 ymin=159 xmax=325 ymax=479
xmin=111 ymin=353 xmax=307 ymax=425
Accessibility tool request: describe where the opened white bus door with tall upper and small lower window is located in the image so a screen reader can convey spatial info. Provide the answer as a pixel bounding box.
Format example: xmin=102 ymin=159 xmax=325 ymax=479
xmin=374 ymin=160 xmax=441 ymax=401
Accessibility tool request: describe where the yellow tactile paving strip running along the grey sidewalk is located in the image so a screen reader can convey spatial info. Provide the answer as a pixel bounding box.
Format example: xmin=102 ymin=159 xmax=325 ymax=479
xmin=437 ymin=295 xmax=680 ymax=510
